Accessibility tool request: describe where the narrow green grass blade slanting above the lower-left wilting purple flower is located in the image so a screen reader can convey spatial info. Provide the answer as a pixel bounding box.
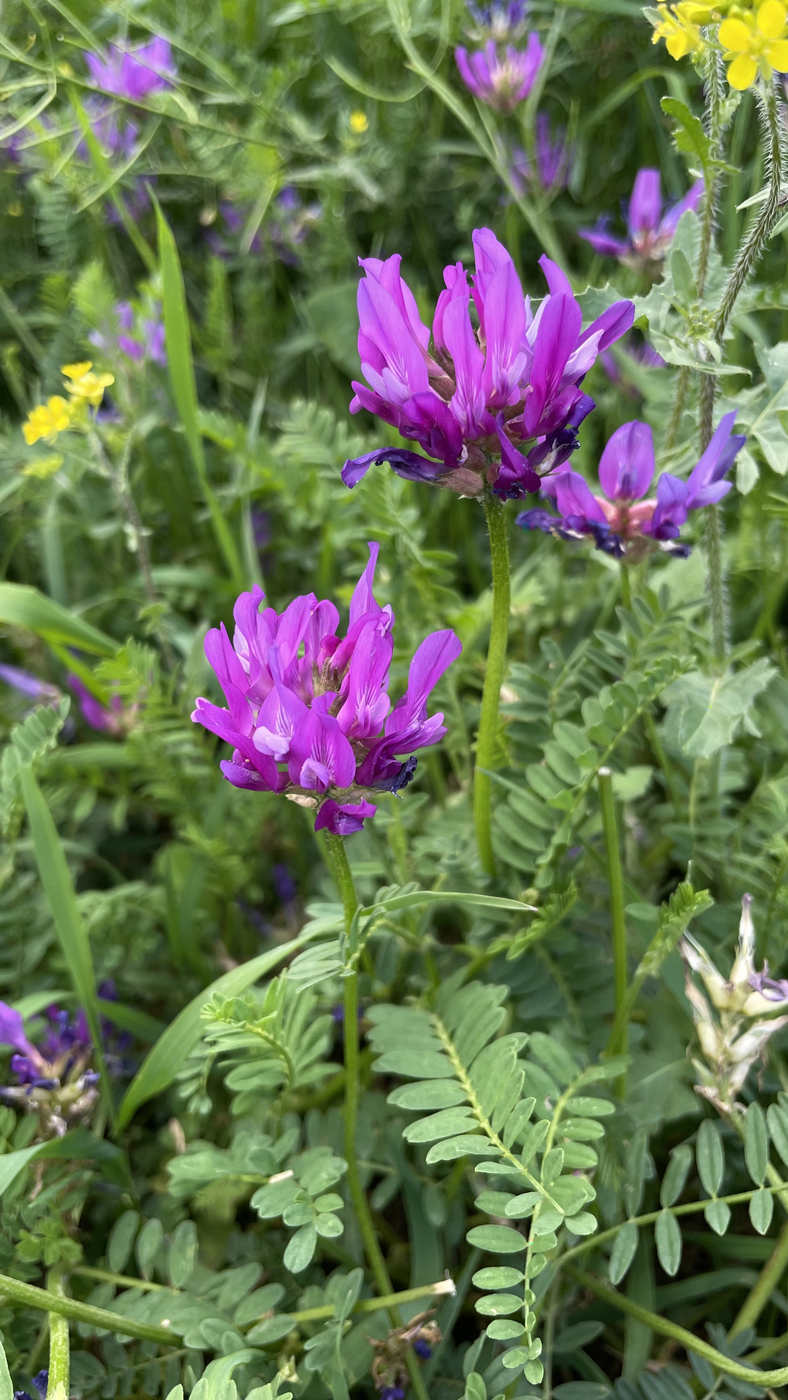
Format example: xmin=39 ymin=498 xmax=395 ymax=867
xmin=20 ymin=767 xmax=115 ymax=1121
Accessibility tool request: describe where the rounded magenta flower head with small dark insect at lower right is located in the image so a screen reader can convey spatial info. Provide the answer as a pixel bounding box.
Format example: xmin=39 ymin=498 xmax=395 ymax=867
xmin=192 ymin=543 xmax=462 ymax=836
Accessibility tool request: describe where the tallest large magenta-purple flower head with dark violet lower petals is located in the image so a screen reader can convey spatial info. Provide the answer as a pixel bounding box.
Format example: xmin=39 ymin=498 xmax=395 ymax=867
xmin=342 ymin=228 xmax=634 ymax=509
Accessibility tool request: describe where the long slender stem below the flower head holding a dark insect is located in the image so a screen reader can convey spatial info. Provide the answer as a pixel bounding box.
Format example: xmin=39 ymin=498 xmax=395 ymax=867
xmin=326 ymin=832 xmax=428 ymax=1400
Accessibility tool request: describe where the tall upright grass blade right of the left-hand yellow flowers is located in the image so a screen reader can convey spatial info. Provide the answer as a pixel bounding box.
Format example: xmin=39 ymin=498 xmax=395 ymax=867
xmin=154 ymin=199 xmax=245 ymax=591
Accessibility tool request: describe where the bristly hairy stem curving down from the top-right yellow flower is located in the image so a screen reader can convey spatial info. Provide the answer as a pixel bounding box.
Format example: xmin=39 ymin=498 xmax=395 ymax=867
xmin=700 ymin=78 xmax=785 ymax=666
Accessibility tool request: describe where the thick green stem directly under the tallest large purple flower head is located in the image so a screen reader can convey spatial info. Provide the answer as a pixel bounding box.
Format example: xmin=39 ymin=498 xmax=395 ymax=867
xmin=473 ymin=491 xmax=509 ymax=875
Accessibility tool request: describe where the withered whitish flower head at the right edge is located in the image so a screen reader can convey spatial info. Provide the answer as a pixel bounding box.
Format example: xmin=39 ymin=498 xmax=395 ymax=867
xmin=680 ymin=895 xmax=788 ymax=1113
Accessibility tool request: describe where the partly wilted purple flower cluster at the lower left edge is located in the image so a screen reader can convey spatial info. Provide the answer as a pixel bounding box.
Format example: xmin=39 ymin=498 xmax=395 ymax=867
xmin=0 ymin=1001 xmax=99 ymax=1137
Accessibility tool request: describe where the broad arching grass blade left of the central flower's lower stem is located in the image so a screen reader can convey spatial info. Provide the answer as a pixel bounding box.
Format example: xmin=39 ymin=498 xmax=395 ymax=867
xmin=118 ymin=932 xmax=324 ymax=1128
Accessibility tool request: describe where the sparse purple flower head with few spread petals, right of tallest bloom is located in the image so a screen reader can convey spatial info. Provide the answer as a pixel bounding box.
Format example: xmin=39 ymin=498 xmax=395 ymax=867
xmin=516 ymin=412 xmax=746 ymax=557
